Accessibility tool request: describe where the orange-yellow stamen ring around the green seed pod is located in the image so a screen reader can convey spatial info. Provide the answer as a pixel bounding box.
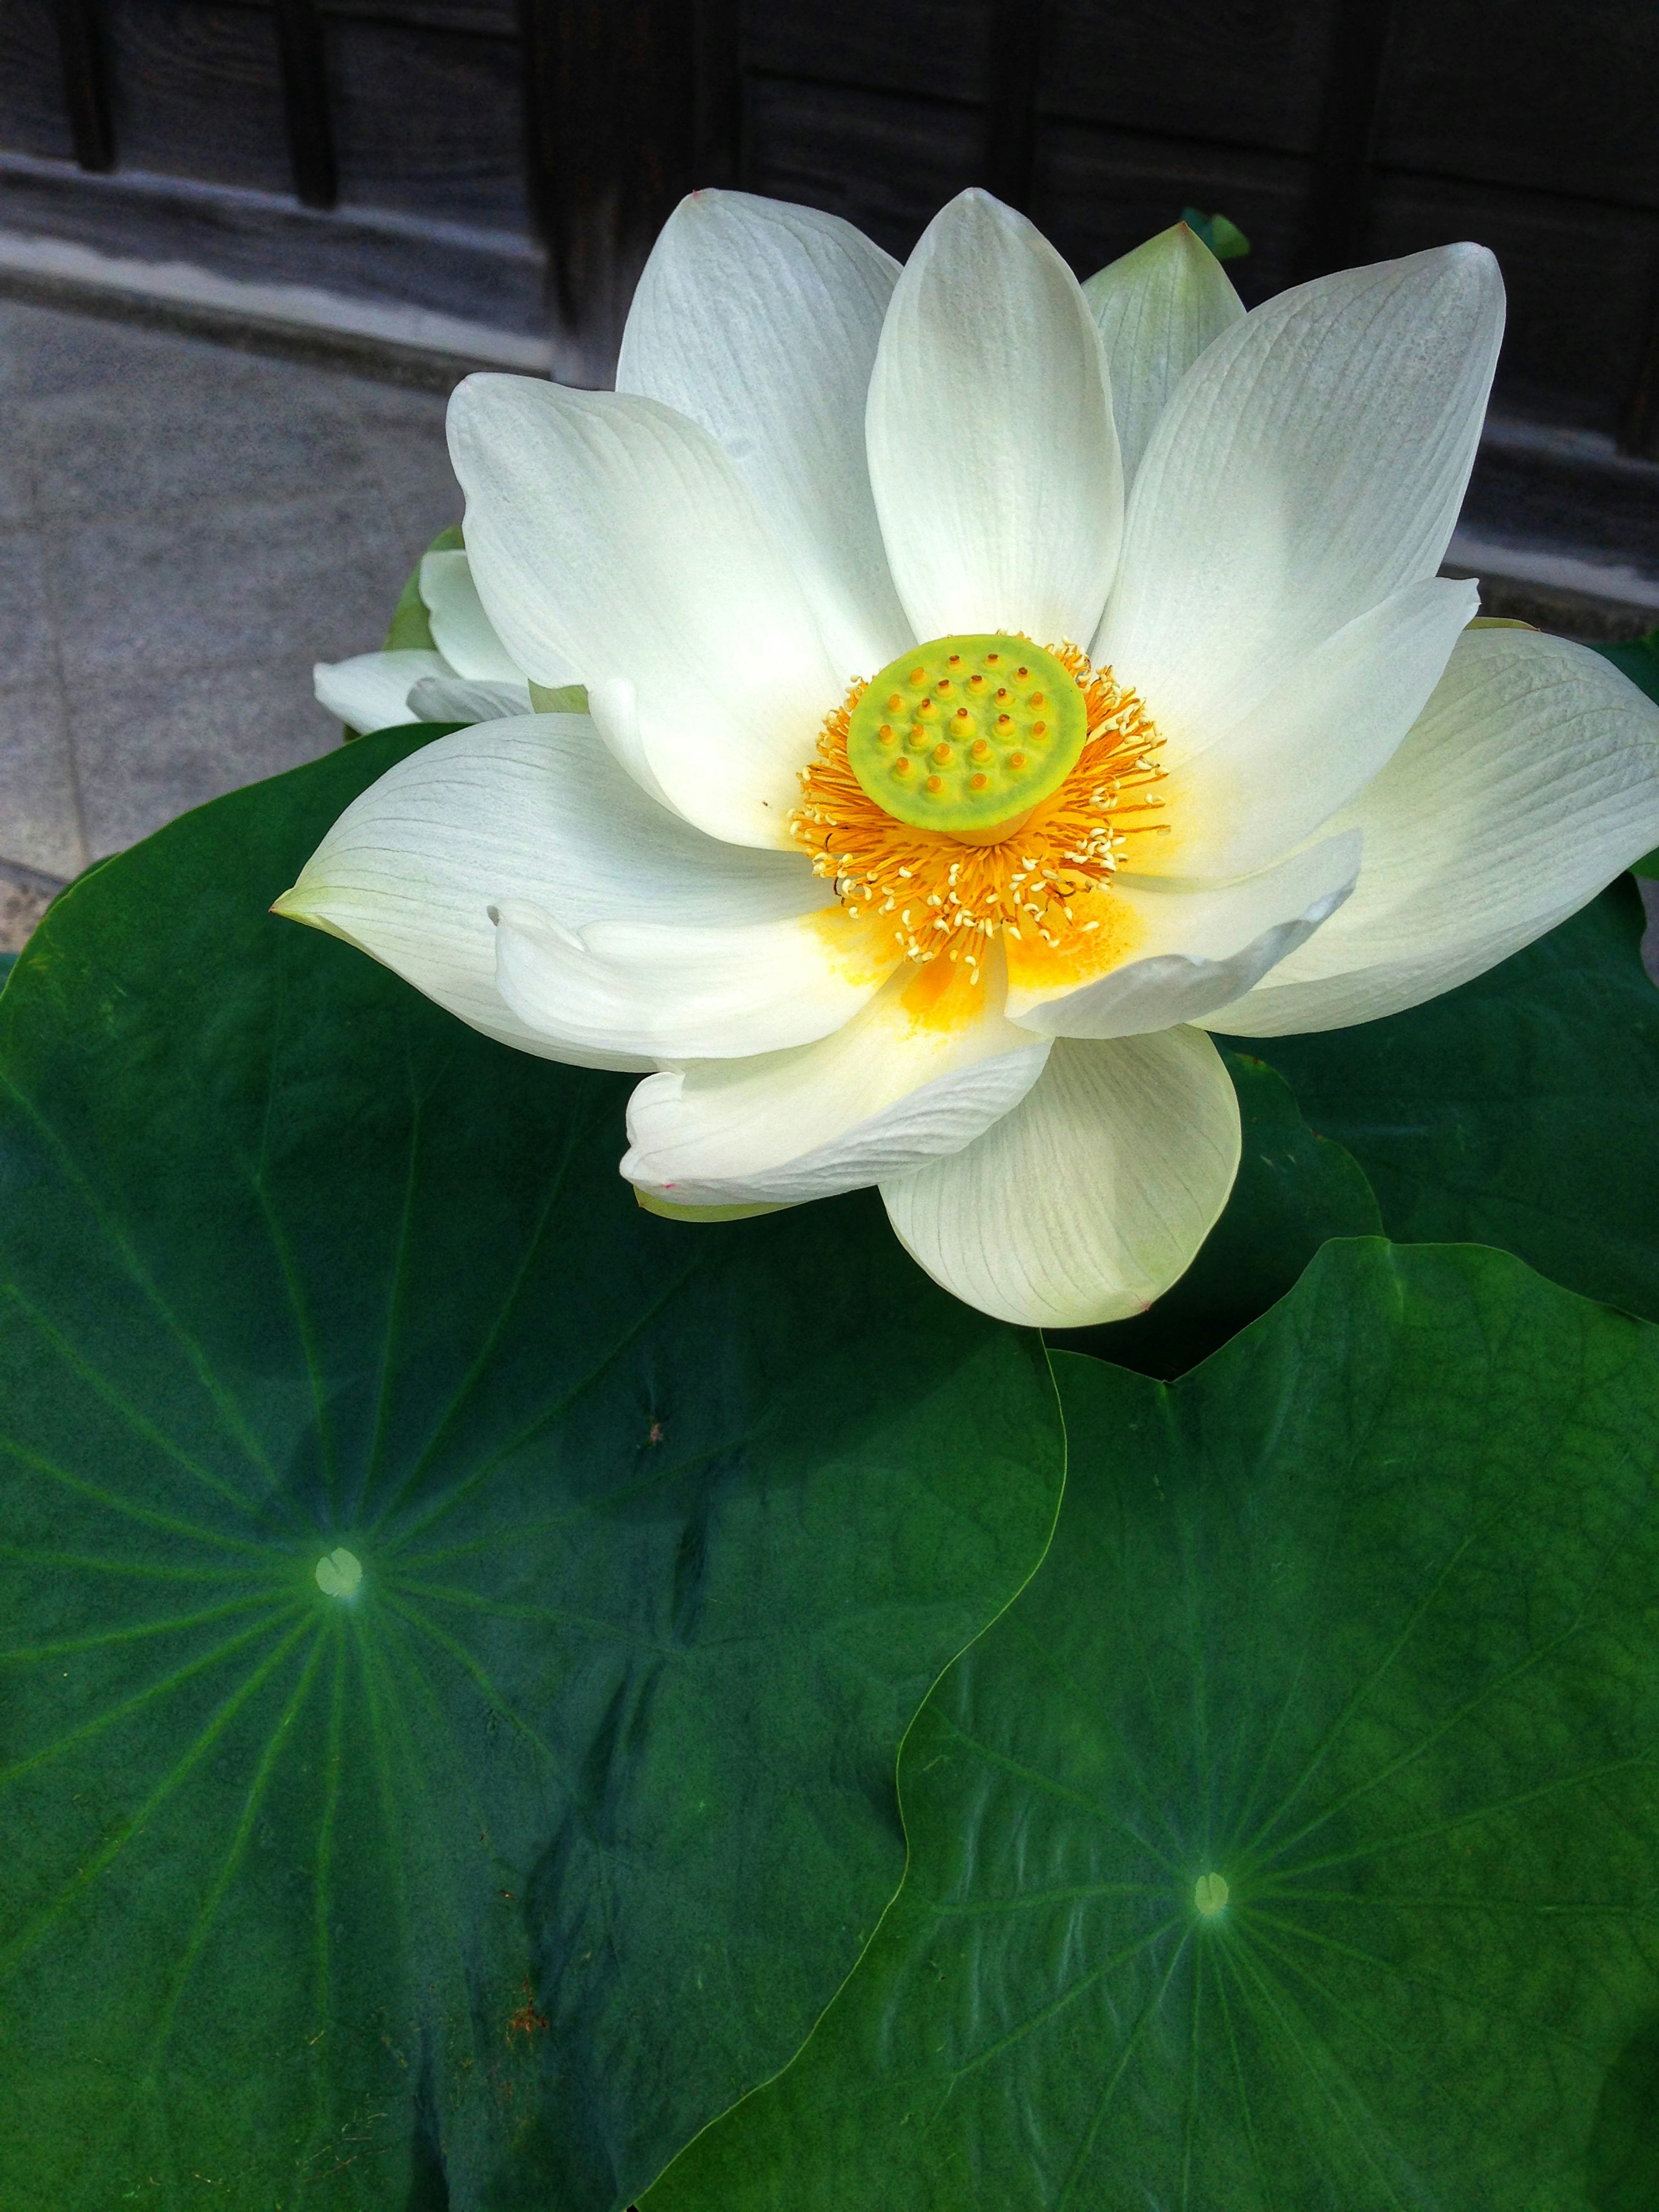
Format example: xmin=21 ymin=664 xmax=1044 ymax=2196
xmin=790 ymin=646 xmax=1163 ymax=980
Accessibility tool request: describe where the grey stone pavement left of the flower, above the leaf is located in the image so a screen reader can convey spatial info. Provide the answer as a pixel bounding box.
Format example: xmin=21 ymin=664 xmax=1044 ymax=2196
xmin=0 ymin=299 xmax=460 ymax=951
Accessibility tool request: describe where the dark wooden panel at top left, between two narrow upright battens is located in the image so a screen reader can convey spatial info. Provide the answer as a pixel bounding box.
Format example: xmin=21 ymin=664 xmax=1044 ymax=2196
xmin=108 ymin=0 xmax=294 ymax=192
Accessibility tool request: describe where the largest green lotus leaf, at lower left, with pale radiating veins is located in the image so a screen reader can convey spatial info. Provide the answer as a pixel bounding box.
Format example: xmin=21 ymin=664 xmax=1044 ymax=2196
xmin=0 ymin=730 xmax=1062 ymax=2212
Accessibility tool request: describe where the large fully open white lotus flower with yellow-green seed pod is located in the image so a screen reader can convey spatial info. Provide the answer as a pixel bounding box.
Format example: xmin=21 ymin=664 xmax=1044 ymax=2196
xmin=279 ymin=192 xmax=1659 ymax=1325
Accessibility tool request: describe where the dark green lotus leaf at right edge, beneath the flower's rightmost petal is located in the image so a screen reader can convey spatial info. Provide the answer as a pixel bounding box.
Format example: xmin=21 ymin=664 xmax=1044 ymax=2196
xmin=1246 ymin=876 xmax=1659 ymax=1321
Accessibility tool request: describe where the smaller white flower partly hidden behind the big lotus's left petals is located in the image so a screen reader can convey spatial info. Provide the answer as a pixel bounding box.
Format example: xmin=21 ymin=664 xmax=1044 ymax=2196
xmin=312 ymin=551 xmax=575 ymax=734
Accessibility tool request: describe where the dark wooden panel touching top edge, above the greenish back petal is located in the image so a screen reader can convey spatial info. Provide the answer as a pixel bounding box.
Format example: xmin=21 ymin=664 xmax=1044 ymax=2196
xmin=1039 ymin=0 xmax=1332 ymax=153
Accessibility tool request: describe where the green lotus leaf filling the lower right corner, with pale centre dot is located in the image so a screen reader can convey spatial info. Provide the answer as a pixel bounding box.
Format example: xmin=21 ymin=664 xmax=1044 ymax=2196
xmin=644 ymin=1241 xmax=1659 ymax=2212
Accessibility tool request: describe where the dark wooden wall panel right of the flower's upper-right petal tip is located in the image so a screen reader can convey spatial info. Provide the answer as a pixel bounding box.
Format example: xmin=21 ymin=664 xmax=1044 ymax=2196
xmin=1369 ymin=175 xmax=1659 ymax=434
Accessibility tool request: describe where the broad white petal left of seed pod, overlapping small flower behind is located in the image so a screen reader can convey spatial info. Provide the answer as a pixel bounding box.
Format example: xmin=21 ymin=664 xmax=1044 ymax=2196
xmin=449 ymin=376 xmax=843 ymax=845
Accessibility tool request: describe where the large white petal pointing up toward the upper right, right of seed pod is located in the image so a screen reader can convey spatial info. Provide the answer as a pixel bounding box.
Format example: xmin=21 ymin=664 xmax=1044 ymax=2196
xmin=1095 ymin=245 xmax=1504 ymax=759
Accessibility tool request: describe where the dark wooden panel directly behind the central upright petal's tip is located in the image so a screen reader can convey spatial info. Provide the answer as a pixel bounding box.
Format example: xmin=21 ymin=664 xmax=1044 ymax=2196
xmin=743 ymin=77 xmax=984 ymax=254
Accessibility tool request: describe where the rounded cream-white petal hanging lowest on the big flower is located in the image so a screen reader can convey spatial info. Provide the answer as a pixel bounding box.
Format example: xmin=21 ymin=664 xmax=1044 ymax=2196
xmin=880 ymin=1029 xmax=1239 ymax=1329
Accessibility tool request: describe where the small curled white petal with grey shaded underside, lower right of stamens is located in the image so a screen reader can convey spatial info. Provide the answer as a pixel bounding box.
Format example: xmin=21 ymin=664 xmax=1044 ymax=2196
xmin=1007 ymin=830 xmax=1360 ymax=1037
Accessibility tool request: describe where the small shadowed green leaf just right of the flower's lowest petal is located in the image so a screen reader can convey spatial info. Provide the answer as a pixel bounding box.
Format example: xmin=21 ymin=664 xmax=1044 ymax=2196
xmin=1046 ymin=1051 xmax=1382 ymax=1378
